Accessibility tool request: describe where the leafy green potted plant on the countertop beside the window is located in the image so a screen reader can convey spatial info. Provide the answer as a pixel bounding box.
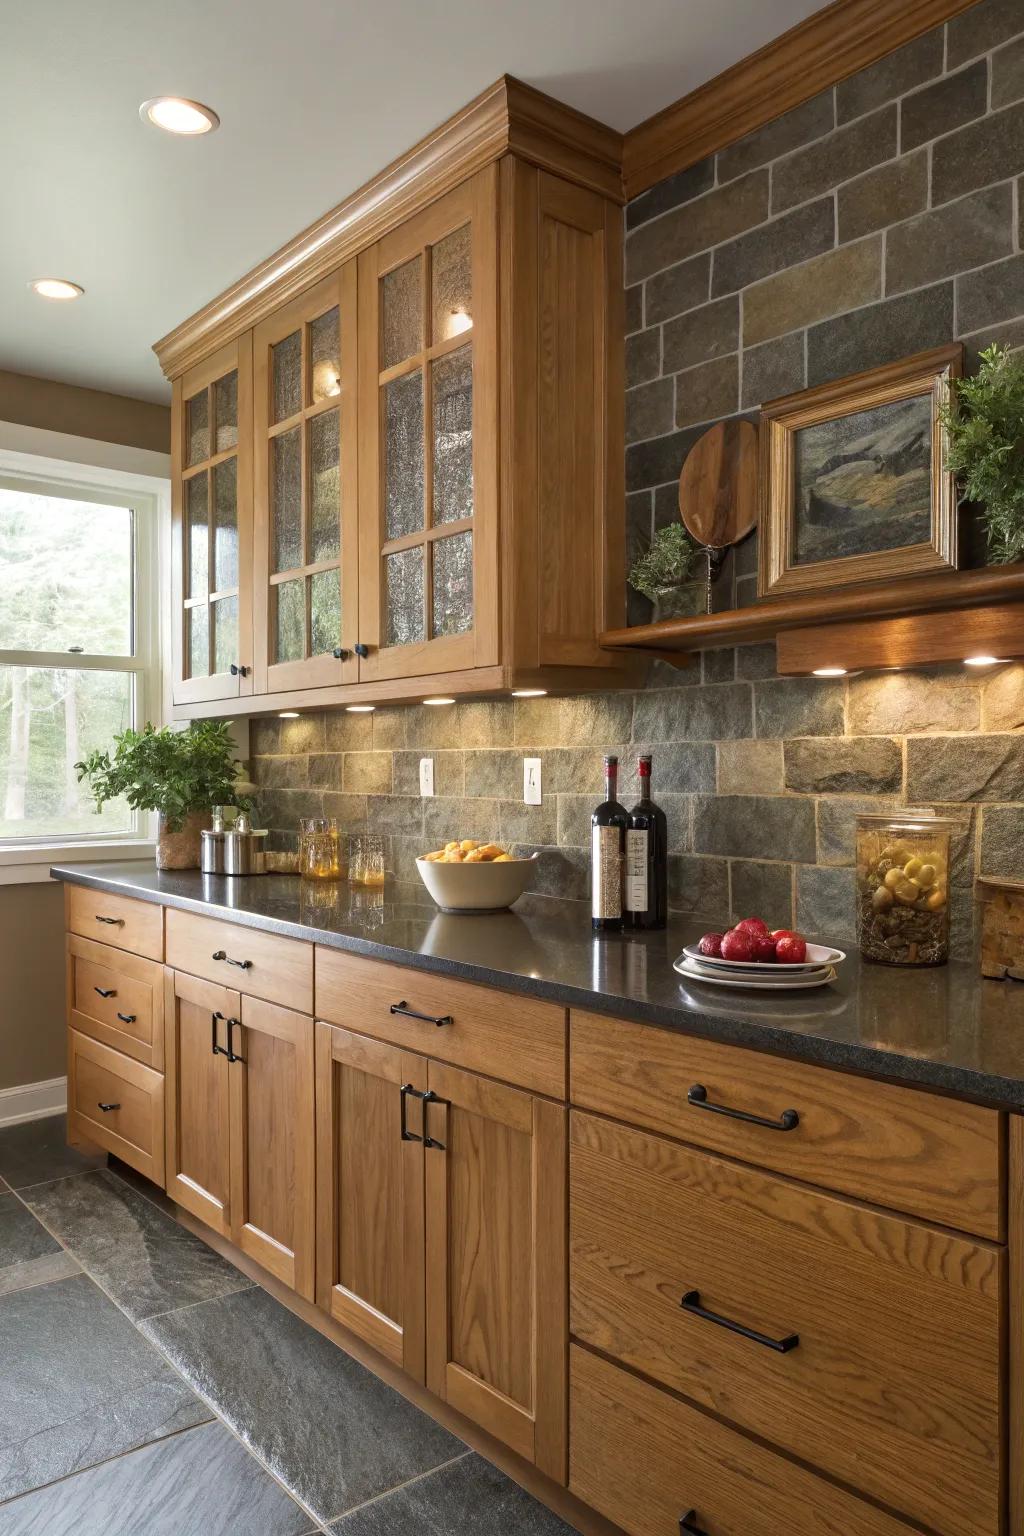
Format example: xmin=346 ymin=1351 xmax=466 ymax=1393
xmin=75 ymin=720 xmax=249 ymax=869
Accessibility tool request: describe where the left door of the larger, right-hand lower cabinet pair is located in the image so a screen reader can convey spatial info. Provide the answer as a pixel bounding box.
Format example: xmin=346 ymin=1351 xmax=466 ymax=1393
xmin=316 ymin=1023 xmax=427 ymax=1381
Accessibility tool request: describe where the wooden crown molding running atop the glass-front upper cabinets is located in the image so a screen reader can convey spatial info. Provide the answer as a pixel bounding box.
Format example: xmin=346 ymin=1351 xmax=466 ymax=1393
xmin=154 ymin=75 xmax=623 ymax=379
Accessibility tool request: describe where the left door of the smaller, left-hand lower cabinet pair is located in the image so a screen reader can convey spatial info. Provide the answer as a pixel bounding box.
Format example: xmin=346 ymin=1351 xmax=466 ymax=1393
xmin=164 ymin=971 xmax=239 ymax=1236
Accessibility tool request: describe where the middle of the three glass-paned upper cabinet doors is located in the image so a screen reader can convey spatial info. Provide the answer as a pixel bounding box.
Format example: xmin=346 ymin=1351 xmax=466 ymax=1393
xmin=253 ymin=261 xmax=359 ymax=693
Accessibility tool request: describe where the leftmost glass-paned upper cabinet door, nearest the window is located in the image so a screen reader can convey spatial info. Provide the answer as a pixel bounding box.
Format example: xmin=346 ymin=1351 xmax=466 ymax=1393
xmin=172 ymin=333 xmax=253 ymax=703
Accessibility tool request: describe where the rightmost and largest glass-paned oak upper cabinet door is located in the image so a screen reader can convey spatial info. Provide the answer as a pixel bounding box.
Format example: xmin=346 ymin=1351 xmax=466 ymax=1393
xmin=359 ymin=166 xmax=499 ymax=680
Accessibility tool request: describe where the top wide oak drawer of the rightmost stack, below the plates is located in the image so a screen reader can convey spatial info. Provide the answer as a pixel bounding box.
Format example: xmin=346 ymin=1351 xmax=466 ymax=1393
xmin=570 ymin=1011 xmax=1004 ymax=1241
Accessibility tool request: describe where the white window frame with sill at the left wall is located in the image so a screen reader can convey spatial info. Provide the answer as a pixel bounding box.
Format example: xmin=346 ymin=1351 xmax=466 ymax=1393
xmin=0 ymin=449 xmax=169 ymax=885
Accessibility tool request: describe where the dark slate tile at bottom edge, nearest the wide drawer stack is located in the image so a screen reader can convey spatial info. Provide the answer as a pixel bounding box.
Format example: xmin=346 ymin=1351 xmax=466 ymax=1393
xmin=334 ymin=1455 xmax=574 ymax=1536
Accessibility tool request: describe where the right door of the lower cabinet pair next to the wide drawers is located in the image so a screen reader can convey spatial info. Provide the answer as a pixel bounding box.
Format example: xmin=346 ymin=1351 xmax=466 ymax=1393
xmin=424 ymin=1061 xmax=567 ymax=1482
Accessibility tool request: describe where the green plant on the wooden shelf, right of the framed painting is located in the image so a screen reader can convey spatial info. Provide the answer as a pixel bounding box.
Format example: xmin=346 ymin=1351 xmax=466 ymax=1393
xmin=941 ymin=343 xmax=1024 ymax=565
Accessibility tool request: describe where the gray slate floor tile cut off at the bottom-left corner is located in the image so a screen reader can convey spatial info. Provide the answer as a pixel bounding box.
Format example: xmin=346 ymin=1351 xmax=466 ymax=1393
xmin=0 ymin=1424 xmax=315 ymax=1536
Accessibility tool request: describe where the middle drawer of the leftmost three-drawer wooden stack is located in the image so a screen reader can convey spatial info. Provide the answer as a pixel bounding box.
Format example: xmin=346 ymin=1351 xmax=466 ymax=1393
xmin=68 ymin=934 xmax=164 ymax=1072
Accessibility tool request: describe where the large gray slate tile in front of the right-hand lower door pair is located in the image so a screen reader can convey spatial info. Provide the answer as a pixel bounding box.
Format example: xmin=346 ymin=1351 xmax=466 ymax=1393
xmin=141 ymin=1289 xmax=464 ymax=1521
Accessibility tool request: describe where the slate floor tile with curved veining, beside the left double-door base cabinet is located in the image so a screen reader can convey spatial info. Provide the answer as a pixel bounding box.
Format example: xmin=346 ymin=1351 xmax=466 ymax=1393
xmin=25 ymin=1169 xmax=252 ymax=1321
